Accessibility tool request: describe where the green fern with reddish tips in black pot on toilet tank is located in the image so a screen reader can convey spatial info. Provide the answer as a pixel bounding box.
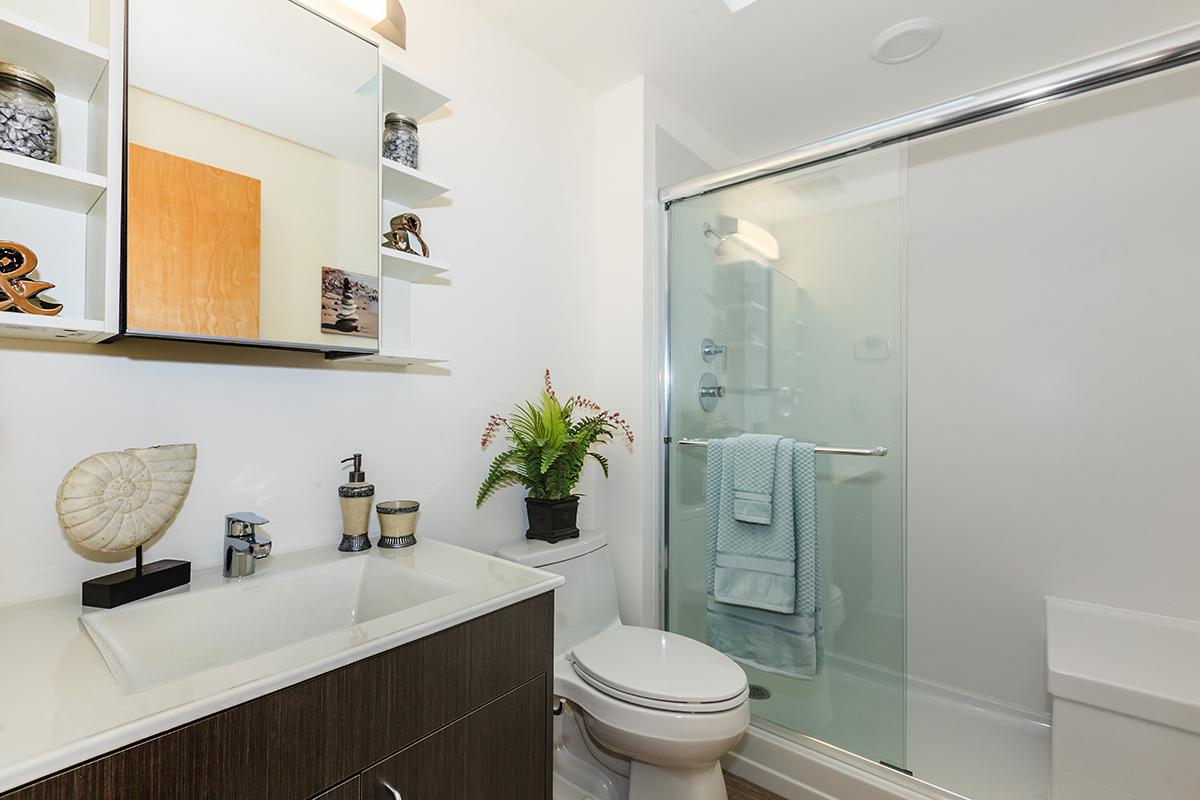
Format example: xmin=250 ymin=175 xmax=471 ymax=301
xmin=475 ymin=369 xmax=634 ymax=542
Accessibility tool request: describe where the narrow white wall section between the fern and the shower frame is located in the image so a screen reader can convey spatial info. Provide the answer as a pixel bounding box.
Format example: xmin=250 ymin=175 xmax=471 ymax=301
xmin=594 ymin=78 xmax=734 ymax=625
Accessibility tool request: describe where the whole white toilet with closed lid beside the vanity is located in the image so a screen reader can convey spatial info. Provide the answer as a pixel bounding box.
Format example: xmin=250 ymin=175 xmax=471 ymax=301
xmin=496 ymin=534 xmax=750 ymax=800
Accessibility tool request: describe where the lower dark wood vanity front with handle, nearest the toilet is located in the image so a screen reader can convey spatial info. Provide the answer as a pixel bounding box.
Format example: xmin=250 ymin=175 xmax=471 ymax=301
xmin=359 ymin=675 xmax=550 ymax=800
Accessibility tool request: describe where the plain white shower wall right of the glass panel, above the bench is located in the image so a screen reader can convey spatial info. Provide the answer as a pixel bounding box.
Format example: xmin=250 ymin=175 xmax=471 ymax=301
xmin=907 ymin=61 xmax=1200 ymax=710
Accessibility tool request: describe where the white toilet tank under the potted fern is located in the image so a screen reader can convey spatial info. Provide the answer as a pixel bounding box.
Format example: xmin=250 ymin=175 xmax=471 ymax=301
xmin=496 ymin=533 xmax=620 ymax=655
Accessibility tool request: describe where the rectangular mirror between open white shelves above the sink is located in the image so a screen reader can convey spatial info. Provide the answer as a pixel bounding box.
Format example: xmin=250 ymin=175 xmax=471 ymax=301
xmin=124 ymin=0 xmax=380 ymax=353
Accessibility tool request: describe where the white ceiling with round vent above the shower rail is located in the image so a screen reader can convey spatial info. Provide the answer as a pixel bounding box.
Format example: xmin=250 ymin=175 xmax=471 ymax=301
xmin=468 ymin=0 xmax=1200 ymax=160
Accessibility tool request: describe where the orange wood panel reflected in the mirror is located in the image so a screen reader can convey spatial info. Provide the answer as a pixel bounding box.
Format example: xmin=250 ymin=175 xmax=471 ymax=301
xmin=126 ymin=144 xmax=262 ymax=338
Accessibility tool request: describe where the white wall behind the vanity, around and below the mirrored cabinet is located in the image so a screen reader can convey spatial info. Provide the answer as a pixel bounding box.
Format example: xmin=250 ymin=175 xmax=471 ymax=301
xmin=0 ymin=0 xmax=600 ymax=604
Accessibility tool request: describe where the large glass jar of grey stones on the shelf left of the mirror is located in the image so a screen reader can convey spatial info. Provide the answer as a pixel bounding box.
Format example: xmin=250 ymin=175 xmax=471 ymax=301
xmin=0 ymin=61 xmax=59 ymax=163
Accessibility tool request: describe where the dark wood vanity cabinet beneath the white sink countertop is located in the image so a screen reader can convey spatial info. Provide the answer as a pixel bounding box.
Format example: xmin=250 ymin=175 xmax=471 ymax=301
xmin=0 ymin=594 xmax=553 ymax=800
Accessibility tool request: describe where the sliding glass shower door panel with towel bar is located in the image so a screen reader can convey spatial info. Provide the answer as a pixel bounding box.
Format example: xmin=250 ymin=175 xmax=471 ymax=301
xmin=666 ymin=146 xmax=906 ymax=768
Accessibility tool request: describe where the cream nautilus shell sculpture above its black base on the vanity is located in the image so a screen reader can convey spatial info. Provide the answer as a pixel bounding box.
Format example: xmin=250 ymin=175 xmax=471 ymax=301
xmin=55 ymin=445 xmax=196 ymax=553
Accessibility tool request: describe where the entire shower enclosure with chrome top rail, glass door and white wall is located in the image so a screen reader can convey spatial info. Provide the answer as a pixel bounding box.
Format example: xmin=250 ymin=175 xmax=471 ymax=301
xmin=662 ymin=28 xmax=1200 ymax=800
